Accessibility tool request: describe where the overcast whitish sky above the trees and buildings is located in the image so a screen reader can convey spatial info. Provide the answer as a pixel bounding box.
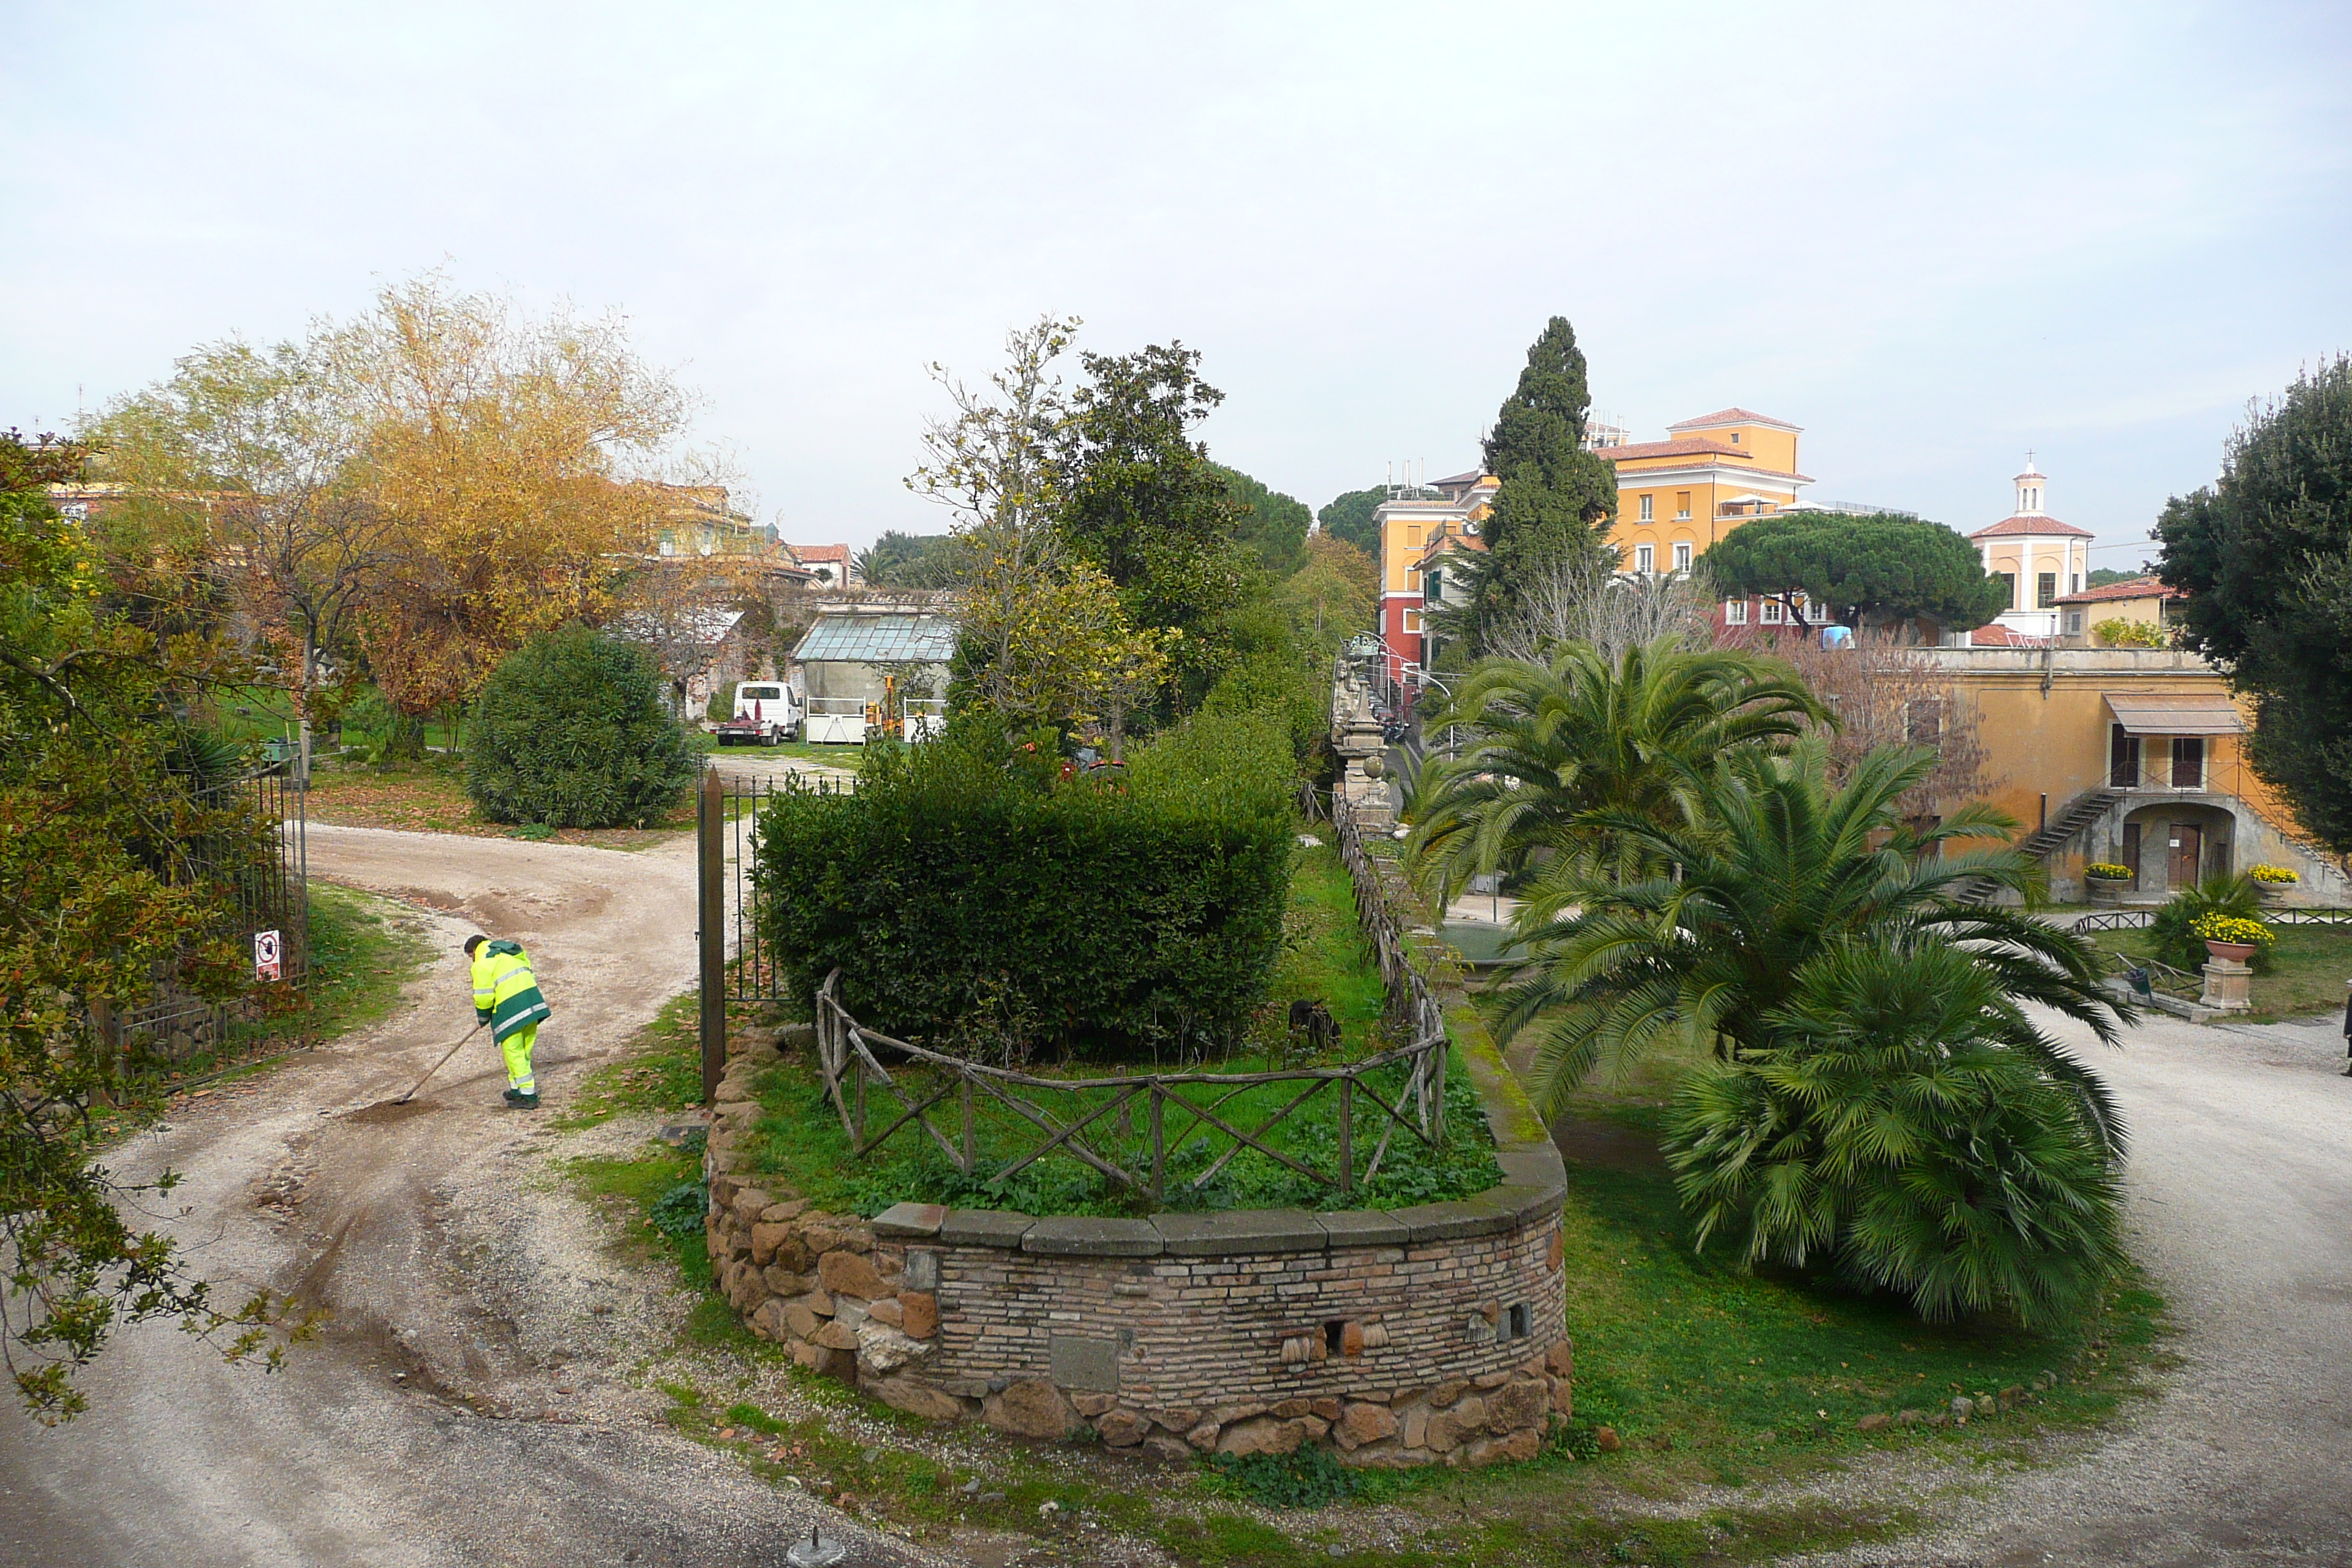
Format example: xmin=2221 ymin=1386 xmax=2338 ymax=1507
xmin=0 ymin=0 xmax=2352 ymax=567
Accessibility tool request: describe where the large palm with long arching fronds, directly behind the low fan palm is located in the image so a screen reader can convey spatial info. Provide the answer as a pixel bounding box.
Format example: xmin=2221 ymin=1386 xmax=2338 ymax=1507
xmin=1496 ymin=738 xmax=2136 ymax=1152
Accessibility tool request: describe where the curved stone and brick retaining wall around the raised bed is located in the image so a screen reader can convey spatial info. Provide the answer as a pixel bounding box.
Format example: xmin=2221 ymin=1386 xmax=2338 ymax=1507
xmin=706 ymin=1030 xmax=1574 ymax=1467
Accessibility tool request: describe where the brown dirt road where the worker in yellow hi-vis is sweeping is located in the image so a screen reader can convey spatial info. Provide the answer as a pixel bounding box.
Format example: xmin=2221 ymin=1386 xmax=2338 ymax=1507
xmin=0 ymin=827 xmax=936 ymax=1568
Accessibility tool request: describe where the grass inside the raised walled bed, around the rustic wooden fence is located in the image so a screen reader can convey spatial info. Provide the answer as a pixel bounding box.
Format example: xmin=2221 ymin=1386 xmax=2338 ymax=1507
xmin=755 ymin=844 xmax=1501 ymax=1215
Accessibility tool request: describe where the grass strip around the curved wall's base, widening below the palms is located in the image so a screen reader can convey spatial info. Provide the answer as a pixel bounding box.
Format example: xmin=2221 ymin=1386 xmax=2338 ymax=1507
xmin=562 ymin=995 xmax=2162 ymax=1568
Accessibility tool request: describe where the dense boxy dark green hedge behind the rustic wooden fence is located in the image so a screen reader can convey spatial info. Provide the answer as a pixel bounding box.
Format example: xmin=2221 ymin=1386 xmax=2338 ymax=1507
xmin=760 ymin=717 xmax=1292 ymax=1060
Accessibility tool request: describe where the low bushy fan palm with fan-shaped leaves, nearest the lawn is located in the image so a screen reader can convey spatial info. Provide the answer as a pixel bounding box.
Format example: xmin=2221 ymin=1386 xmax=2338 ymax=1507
xmin=1665 ymin=943 xmax=2122 ymax=1326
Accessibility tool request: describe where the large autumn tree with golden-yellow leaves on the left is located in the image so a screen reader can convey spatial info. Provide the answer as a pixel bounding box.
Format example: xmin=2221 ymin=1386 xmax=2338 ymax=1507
xmin=91 ymin=273 xmax=689 ymax=761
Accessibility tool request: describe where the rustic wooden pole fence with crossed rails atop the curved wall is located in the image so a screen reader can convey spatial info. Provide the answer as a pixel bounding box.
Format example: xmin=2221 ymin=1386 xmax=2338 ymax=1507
xmin=816 ymin=807 xmax=1447 ymax=1204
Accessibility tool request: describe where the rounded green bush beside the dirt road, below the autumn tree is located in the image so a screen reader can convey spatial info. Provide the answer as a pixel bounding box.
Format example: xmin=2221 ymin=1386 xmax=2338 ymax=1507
xmin=466 ymin=625 xmax=698 ymax=827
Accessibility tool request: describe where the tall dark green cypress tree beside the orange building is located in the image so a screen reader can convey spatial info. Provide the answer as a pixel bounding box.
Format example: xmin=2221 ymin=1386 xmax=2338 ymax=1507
xmin=1447 ymin=315 xmax=1616 ymax=654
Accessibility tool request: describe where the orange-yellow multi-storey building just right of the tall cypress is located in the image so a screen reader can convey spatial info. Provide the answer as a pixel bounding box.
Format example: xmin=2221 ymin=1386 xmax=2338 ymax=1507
xmin=1597 ymin=409 xmax=1814 ymax=571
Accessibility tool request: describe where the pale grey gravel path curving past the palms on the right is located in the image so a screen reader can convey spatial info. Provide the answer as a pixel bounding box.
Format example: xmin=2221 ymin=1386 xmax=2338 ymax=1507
xmin=1825 ymin=1016 xmax=2352 ymax=1568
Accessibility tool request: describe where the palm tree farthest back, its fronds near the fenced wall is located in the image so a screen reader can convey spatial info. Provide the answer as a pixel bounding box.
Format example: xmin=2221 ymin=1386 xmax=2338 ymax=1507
xmin=1406 ymin=637 xmax=1825 ymax=902
